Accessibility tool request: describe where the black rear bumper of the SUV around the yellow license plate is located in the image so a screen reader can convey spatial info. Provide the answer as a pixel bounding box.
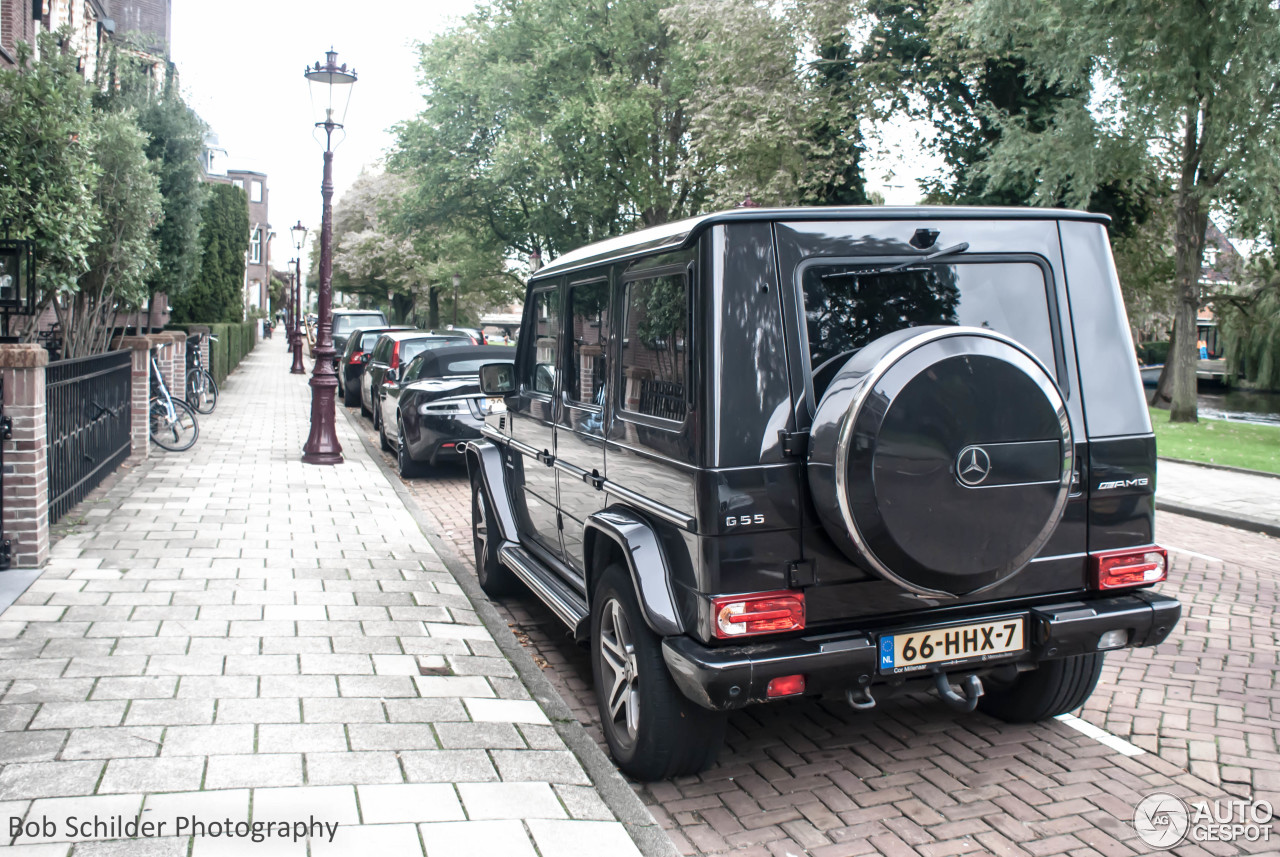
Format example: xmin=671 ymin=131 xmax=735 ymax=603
xmin=662 ymin=591 xmax=1181 ymax=710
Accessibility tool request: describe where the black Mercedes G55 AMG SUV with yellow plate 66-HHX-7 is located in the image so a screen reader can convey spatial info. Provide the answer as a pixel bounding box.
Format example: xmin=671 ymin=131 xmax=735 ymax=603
xmin=467 ymin=207 xmax=1180 ymax=779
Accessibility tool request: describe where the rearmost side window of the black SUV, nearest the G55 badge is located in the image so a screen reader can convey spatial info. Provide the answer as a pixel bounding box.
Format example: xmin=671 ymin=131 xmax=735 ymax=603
xmin=622 ymin=274 xmax=689 ymax=421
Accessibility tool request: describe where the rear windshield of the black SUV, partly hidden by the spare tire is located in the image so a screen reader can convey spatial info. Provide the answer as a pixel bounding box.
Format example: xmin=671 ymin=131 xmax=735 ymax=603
xmin=801 ymin=262 xmax=1057 ymax=376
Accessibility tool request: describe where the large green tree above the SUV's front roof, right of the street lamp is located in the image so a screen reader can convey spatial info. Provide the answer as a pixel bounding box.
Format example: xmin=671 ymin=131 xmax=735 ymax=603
xmin=390 ymin=0 xmax=704 ymax=260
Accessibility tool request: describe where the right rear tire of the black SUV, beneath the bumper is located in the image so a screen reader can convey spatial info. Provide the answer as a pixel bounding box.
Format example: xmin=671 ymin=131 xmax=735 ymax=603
xmin=978 ymin=652 xmax=1105 ymax=723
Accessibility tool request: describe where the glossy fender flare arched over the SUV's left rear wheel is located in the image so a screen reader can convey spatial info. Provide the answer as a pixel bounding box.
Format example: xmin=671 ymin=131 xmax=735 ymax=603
xmin=582 ymin=507 xmax=685 ymax=637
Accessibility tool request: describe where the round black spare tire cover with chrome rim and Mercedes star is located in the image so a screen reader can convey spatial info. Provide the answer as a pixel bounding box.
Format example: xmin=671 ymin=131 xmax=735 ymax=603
xmin=808 ymin=326 xmax=1073 ymax=596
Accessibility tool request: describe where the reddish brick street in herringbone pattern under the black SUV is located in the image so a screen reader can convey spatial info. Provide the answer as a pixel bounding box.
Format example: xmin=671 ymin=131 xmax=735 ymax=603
xmin=353 ymin=414 xmax=1280 ymax=857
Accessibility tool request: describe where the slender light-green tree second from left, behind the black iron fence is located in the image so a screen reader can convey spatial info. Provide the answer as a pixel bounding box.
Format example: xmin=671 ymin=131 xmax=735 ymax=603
xmin=54 ymin=113 xmax=160 ymax=357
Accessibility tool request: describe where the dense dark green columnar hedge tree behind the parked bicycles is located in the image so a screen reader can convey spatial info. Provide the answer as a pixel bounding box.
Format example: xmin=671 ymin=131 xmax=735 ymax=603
xmin=173 ymin=184 xmax=248 ymax=324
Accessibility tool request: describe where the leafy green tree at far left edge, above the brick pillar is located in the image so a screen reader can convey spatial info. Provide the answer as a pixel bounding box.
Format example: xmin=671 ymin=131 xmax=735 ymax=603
xmin=0 ymin=33 xmax=100 ymax=307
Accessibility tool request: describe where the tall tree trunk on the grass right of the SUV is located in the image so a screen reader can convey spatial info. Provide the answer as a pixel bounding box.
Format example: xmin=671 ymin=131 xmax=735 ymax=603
xmin=1165 ymin=105 xmax=1208 ymax=422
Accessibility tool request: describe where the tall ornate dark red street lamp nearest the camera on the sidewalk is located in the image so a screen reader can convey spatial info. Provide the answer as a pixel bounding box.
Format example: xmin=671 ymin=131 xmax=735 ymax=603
xmin=302 ymin=49 xmax=356 ymax=464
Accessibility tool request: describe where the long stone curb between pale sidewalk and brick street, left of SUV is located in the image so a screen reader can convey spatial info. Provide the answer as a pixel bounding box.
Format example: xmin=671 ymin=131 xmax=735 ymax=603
xmin=339 ymin=405 xmax=680 ymax=857
